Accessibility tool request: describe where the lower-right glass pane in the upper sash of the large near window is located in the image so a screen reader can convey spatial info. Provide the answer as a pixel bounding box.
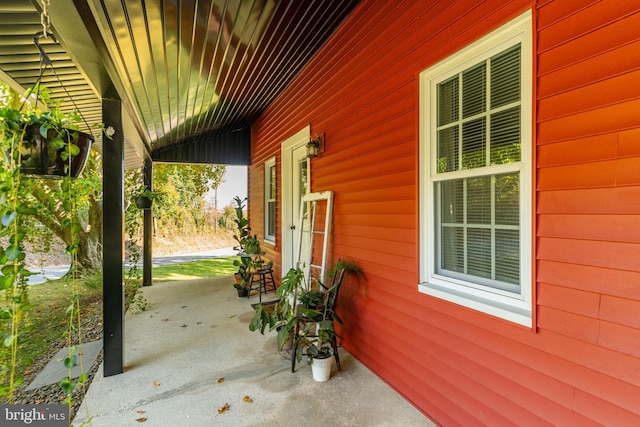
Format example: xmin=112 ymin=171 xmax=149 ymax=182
xmin=491 ymin=106 xmax=520 ymax=165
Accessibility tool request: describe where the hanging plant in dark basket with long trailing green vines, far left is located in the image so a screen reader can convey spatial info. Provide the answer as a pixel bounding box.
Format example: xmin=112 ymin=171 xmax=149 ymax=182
xmin=0 ymin=24 xmax=113 ymax=418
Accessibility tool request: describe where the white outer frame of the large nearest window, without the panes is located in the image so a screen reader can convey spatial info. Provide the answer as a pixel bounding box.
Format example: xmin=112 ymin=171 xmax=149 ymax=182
xmin=418 ymin=10 xmax=533 ymax=327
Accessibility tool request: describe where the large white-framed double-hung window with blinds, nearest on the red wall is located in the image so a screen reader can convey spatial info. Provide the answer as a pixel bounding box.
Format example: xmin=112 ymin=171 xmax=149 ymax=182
xmin=420 ymin=13 xmax=532 ymax=326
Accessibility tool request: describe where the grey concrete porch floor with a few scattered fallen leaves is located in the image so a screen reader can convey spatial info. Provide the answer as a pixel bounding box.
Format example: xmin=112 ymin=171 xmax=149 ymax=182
xmin=73 ymin=277 xmax=434 ymax=427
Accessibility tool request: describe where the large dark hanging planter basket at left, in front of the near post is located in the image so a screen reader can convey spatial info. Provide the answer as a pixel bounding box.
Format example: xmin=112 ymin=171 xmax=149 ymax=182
xmin=21 ymin=124 xmax=93 ymax=178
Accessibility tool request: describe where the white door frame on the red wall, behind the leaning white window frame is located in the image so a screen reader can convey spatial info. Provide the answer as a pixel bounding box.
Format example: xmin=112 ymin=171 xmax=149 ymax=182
xmin=280 ymin=125 xmax=311 ymax=274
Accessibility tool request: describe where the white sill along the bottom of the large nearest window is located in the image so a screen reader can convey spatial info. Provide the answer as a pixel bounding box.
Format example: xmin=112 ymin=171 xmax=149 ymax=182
xmin=418 ymin=283 xmax=532 ymax=328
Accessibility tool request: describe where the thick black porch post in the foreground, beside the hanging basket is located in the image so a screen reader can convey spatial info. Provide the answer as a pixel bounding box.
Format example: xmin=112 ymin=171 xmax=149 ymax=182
xmin=102 ymin=95 xmax=124 ymax=377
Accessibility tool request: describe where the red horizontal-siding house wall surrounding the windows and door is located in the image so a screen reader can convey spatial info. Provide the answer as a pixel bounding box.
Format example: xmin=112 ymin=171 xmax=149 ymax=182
xmin=250 ymin=0 xmax=640 ymax=426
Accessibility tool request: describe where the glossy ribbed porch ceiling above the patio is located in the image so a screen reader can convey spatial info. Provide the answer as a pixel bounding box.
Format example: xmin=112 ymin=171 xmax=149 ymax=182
xmin=0 ymin=0 xmax=358 ymax=169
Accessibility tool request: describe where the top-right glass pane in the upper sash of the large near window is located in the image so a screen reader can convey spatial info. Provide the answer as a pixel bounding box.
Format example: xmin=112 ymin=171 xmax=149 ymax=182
xmin=491 ymin=44 xmax=520 ymax=108
